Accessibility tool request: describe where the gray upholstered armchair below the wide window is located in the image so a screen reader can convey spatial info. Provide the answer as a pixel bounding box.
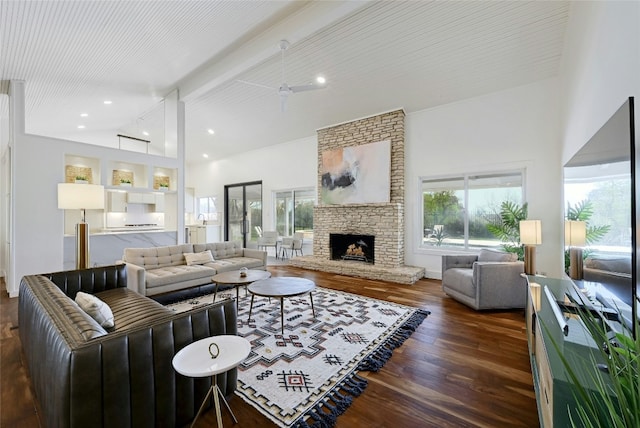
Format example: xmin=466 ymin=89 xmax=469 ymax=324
xmin=442 ymin=249 xmax=527 ymax=310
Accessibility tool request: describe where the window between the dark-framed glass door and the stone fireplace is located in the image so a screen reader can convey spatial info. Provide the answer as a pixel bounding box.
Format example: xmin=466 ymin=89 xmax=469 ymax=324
xmin=275 ymin=189 xmax=316 ymax=236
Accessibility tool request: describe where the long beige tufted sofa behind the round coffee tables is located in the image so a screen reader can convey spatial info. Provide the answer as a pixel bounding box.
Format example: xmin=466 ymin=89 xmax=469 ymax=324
xmin=123 ymin=241 xmax=267 ymax=296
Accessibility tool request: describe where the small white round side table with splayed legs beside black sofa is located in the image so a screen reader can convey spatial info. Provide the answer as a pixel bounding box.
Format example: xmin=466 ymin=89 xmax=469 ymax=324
xmin=172 ymin=335 xmax=251 ymax=428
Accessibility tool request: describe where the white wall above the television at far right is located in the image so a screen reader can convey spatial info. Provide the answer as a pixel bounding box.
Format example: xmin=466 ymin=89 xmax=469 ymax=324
xmin=561 ymin=1 xmax=640 ymax=164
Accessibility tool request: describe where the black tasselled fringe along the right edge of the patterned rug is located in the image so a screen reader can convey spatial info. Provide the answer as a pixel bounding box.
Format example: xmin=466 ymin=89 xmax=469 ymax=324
xmin=292 ymin=309 xmax=431 ymax=428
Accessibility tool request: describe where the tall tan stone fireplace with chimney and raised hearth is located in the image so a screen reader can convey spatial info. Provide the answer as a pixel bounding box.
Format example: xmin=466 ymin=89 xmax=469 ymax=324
xmin=290 ymin=110 xmax=424 ymax=284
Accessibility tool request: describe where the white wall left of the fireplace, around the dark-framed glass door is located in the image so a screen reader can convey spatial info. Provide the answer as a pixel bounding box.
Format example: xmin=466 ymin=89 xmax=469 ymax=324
xmin=185 ymin=135 xmax=318 ymax=228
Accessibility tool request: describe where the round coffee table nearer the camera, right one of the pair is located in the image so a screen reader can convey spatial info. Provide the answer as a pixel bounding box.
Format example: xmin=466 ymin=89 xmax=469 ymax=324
xmin=247 ymin=276 xmax=316 ymax=334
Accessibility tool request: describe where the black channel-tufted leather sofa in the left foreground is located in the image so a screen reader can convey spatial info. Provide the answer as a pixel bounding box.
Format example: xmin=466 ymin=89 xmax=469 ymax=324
xmin=18 ymin=264 xmax=237 ymax=428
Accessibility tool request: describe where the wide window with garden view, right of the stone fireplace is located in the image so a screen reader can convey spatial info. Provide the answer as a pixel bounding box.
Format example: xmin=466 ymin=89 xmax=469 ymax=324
xmin=421 ymin=171 xmax=524 ymax=249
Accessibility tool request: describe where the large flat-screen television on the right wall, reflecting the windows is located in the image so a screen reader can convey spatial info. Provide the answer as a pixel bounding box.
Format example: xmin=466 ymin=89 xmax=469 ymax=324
xmin=564 ymin=97 xmax=640 ymax=337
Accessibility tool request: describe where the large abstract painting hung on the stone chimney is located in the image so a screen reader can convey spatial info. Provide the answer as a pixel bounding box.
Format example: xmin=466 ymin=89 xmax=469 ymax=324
xmin=321 ymin=140 xmax=391 ymax=205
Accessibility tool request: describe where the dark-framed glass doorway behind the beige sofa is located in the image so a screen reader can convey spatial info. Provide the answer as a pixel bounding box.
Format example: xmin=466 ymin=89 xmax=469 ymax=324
xmin=224 ymin=181 xmax=262 ymax=248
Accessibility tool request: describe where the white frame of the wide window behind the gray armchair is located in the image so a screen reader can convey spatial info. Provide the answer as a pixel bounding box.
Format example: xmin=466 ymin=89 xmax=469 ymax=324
xmin=414 ymin=167 xmax=527 ymax=255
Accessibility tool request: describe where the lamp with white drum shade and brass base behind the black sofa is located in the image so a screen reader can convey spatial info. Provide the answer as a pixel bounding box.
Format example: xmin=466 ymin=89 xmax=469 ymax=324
xmin=58 ymin=183 xmax=104 ymax=269
